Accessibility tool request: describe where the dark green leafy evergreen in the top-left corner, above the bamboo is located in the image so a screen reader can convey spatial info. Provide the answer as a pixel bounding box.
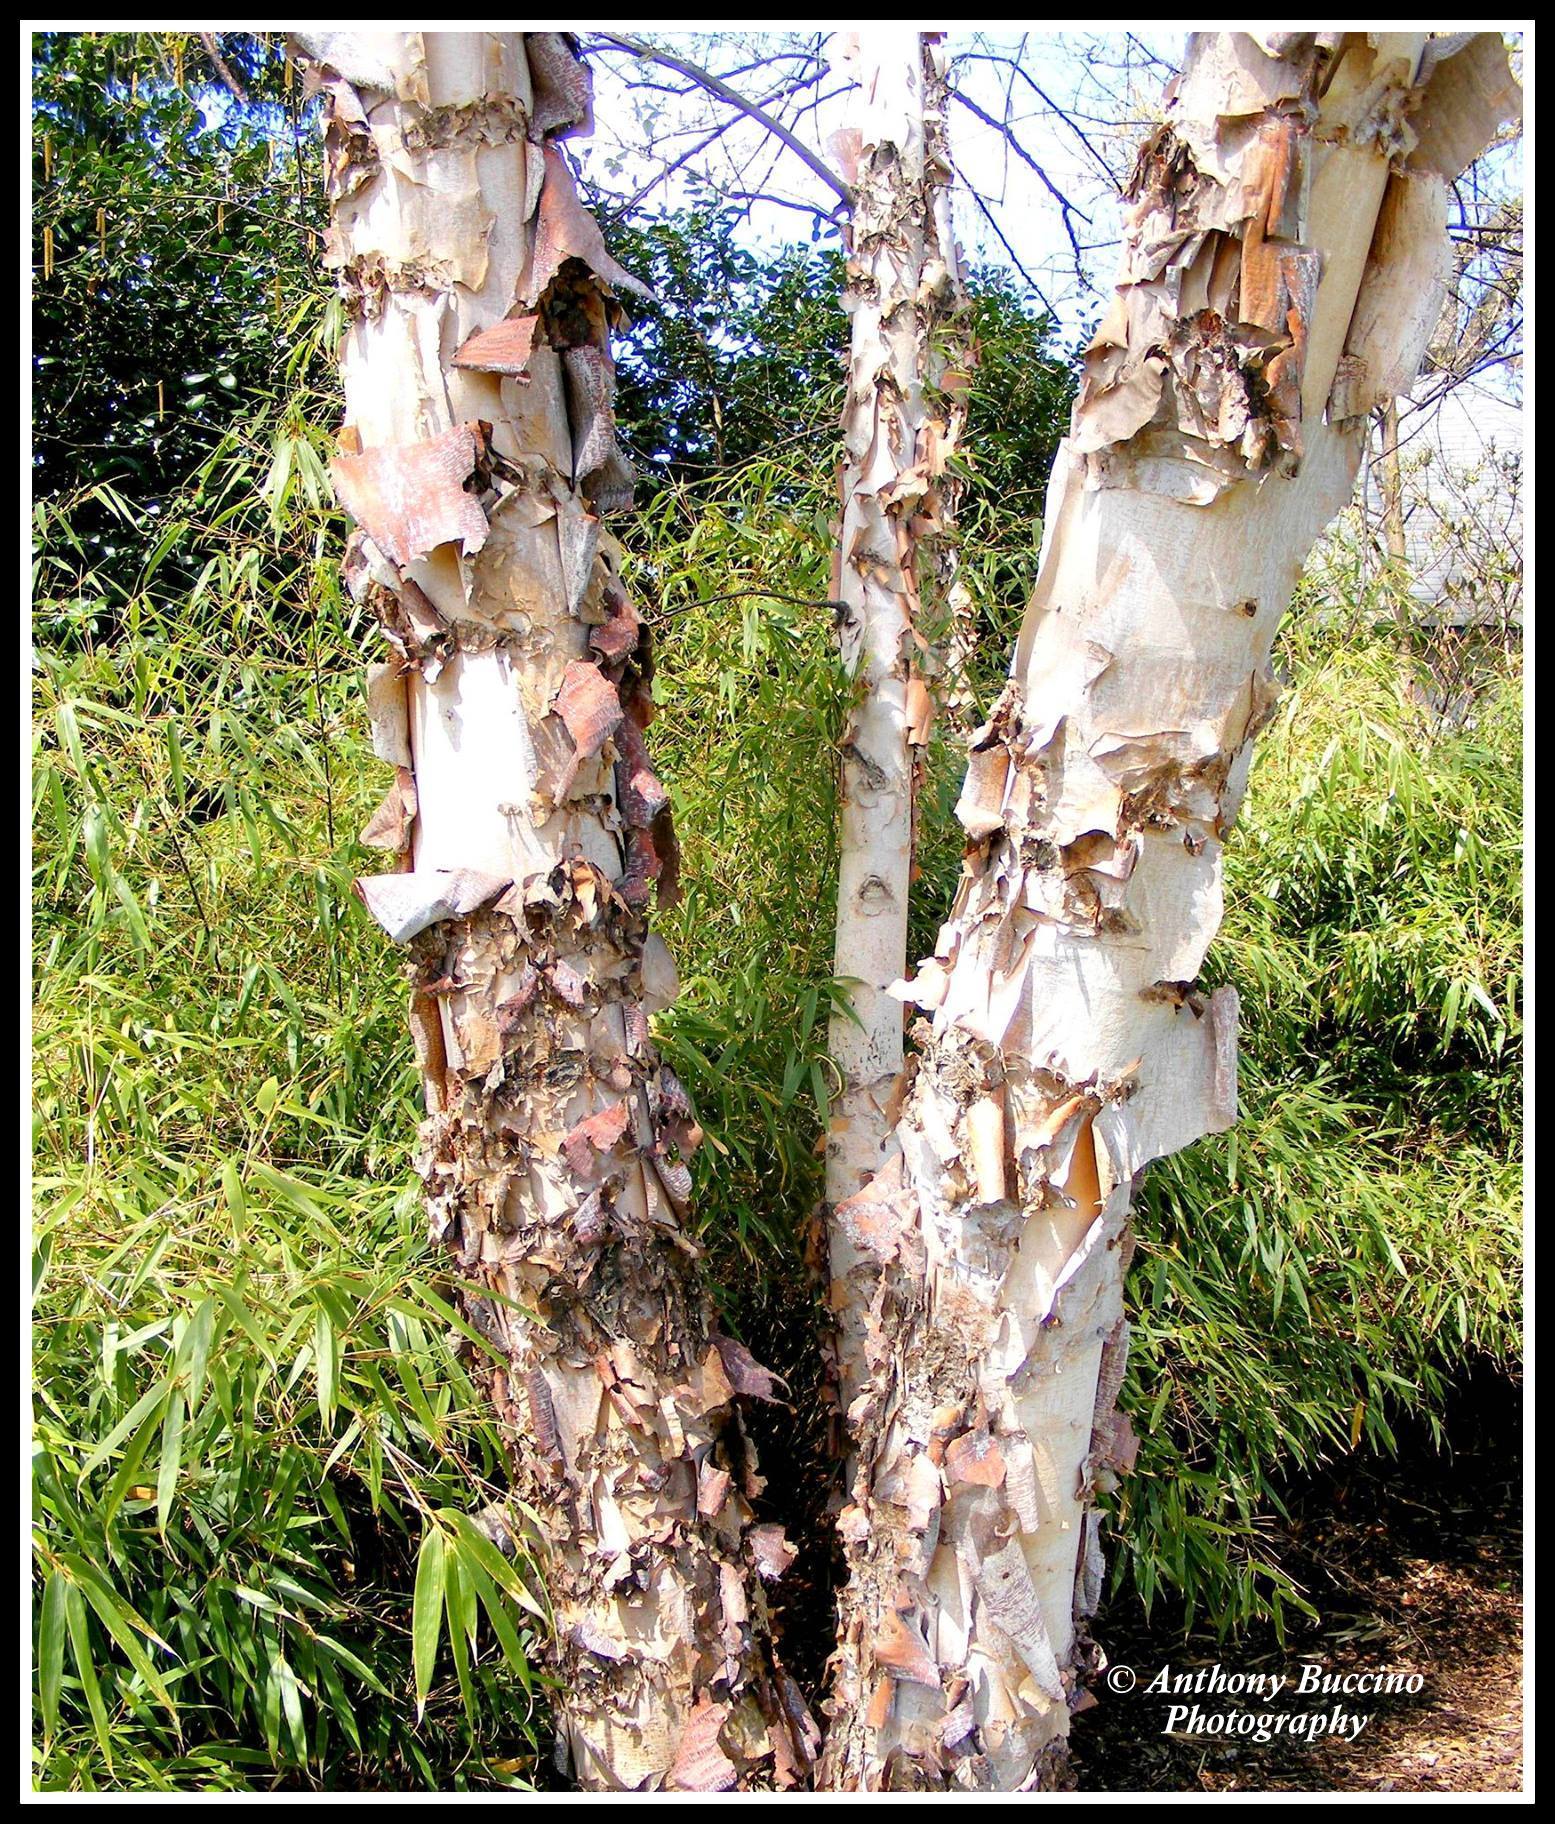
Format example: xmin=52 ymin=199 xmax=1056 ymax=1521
xmin=31 ymin=33 xmax=323 ymax=583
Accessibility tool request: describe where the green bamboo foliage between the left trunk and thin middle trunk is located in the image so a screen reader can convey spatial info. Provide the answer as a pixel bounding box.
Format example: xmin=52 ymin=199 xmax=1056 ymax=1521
xmin=631 ymin=452 xmax=844 ymax=1269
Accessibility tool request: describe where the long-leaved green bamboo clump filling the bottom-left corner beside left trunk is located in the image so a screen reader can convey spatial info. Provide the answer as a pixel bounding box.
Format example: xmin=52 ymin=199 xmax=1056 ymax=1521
xmin=33 ymin=1160 xmax=543 ymax=1789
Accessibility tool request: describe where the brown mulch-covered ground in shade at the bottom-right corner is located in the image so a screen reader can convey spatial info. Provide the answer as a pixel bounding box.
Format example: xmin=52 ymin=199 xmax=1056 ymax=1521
xmin=1072 ymin=1379 xmax=1522 ymax=1793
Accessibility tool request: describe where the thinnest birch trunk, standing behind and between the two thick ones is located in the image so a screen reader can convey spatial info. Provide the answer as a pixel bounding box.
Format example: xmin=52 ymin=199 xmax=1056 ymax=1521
xmin=826 ymin=27 xmax=964 ymax=1410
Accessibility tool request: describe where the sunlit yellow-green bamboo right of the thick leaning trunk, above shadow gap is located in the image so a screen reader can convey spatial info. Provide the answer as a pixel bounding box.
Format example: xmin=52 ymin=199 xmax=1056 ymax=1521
xmin=1221 ymin=561 xmax=1522 ymax=1153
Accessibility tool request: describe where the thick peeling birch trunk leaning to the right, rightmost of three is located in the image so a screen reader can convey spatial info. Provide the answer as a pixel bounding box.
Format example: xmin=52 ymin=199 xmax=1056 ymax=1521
xmin=822 ymin=33 xmax=1513 ymax=1789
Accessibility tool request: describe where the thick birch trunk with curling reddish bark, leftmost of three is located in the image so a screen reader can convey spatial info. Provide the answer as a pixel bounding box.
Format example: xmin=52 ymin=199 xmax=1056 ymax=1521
xmin=303 ymin=31 xmax=815 ymax=1788
